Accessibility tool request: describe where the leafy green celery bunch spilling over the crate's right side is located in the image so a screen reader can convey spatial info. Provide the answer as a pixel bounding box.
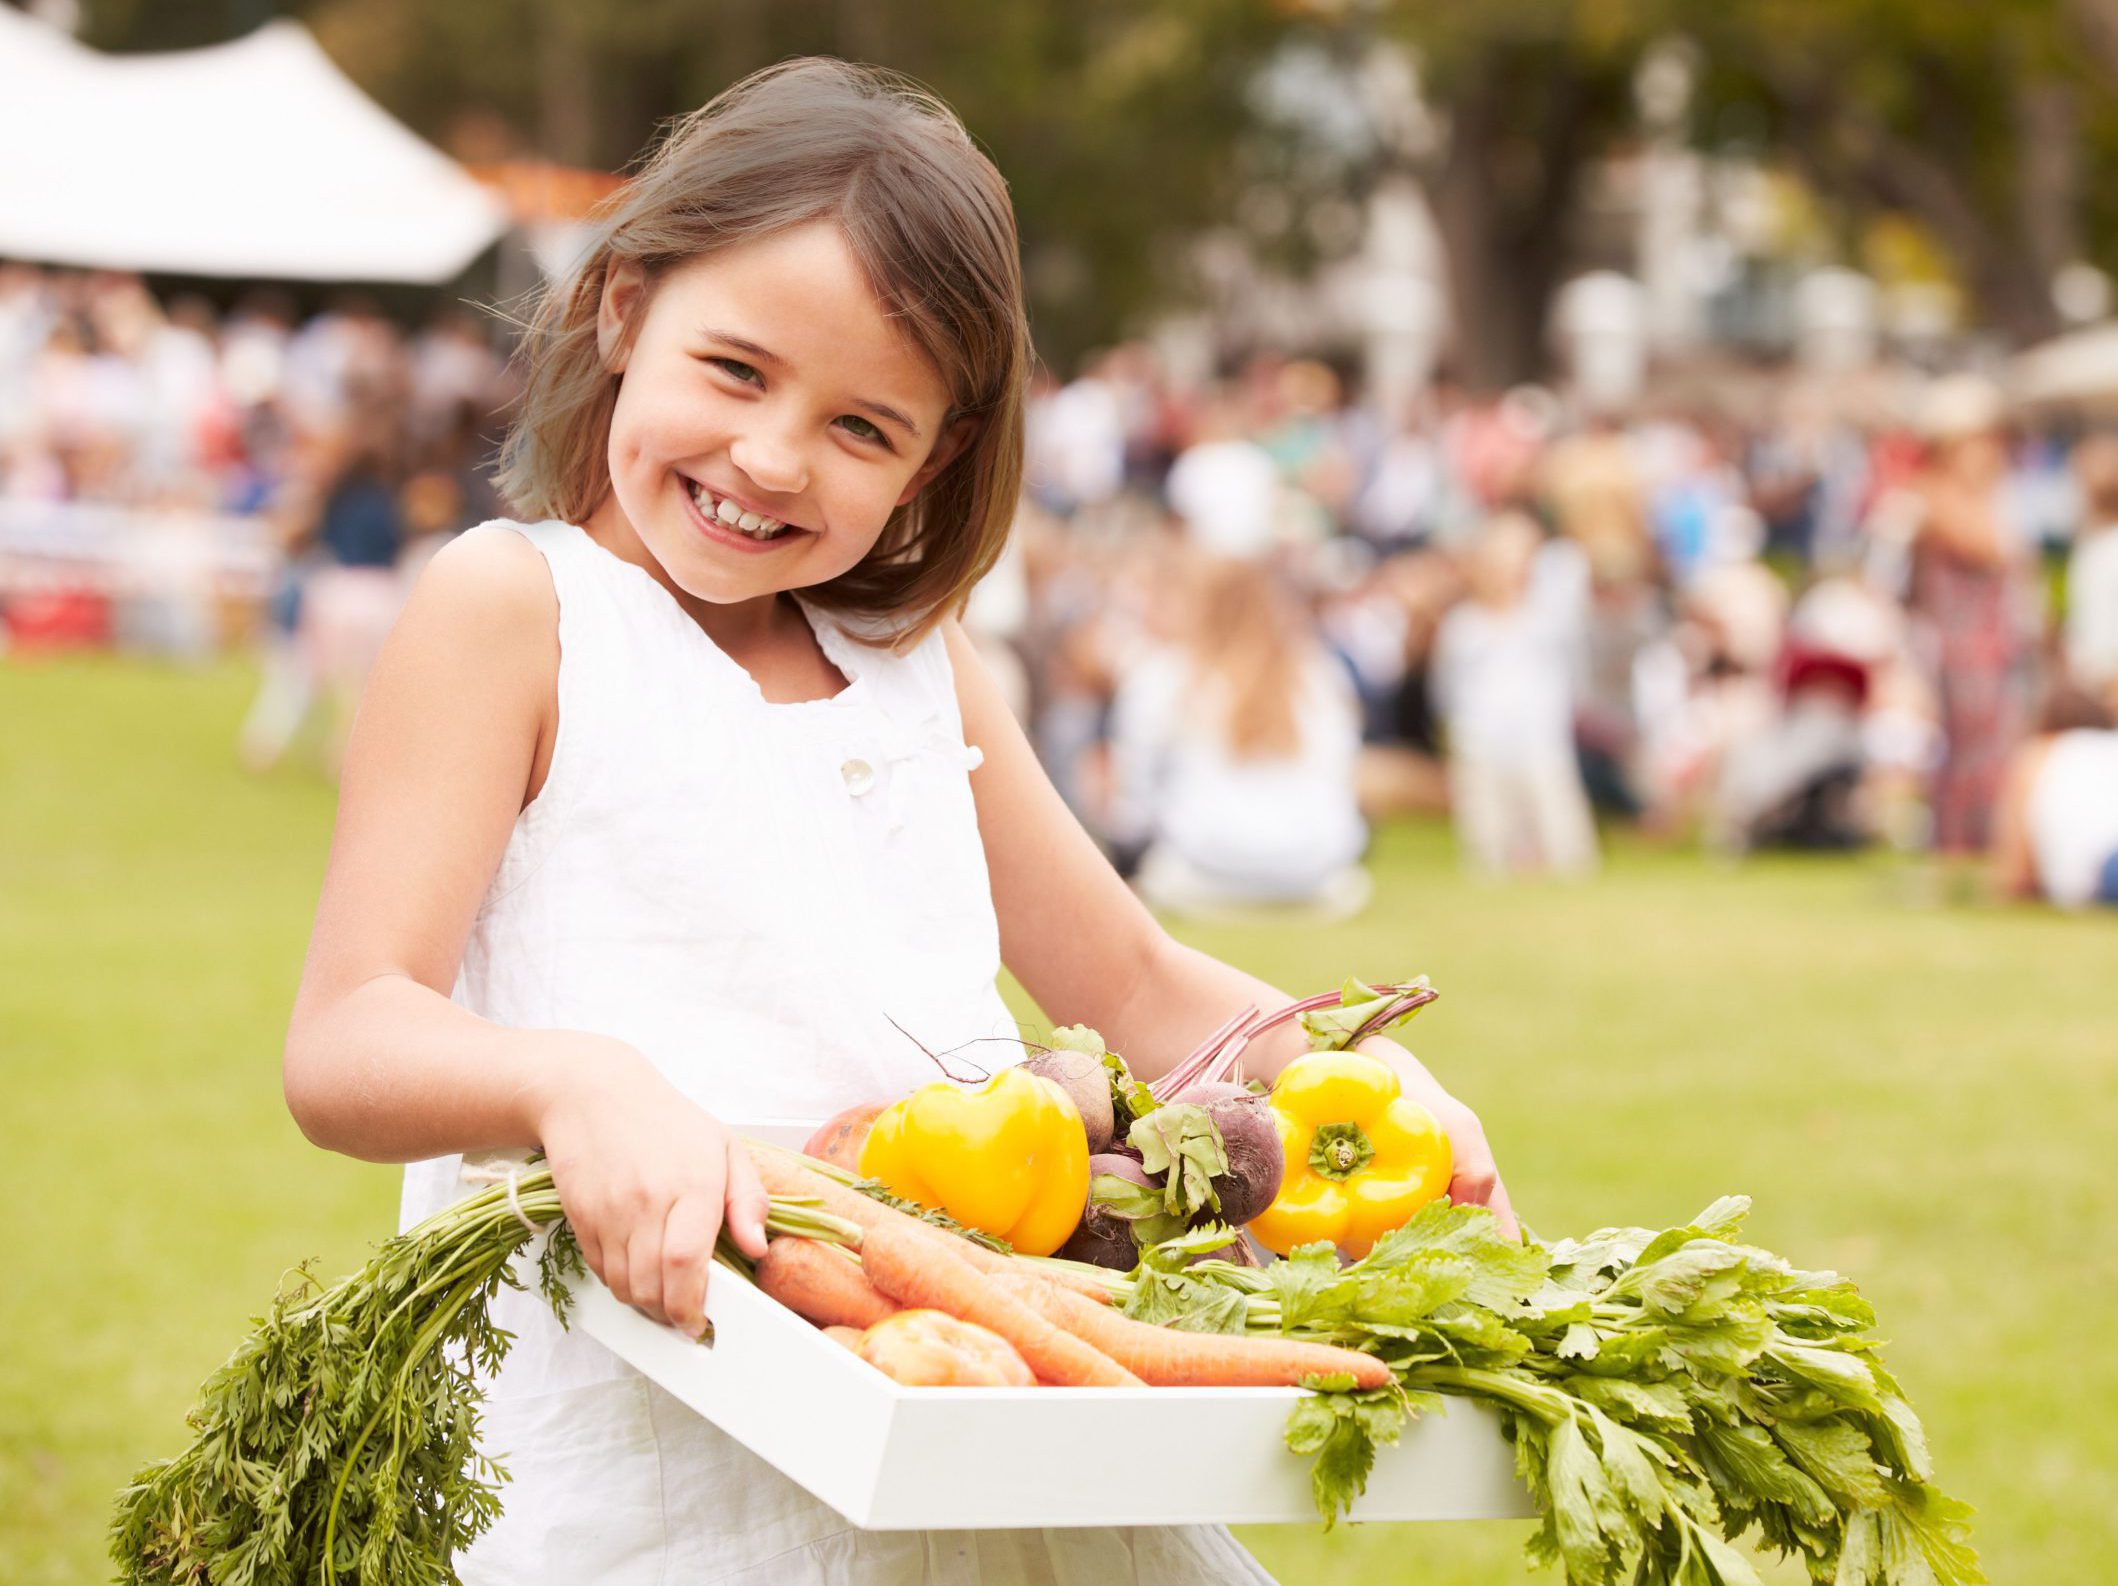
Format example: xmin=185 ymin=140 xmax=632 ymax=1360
xmin=1127 ymin=1196 xmax=1985 ymax=1586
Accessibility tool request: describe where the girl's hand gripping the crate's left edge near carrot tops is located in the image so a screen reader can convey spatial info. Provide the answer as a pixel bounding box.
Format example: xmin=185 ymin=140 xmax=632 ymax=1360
xmin=538 ymin=1035 xmax=767 ymax=1336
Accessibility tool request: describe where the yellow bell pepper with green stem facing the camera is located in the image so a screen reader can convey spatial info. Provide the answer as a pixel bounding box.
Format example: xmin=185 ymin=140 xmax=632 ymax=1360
xmin=1250 ymin=1052 xmax=1455 ymax=1256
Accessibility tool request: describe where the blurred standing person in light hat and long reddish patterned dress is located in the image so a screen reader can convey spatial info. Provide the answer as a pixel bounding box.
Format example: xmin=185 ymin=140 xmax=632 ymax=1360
xmin=1908 ymin=375 xmax=2033 ymax=858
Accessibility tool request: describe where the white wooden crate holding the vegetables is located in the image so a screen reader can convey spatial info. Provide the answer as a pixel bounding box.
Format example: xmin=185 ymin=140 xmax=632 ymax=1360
xmin=574 ymin=1122 xmax=1536 ymax=1531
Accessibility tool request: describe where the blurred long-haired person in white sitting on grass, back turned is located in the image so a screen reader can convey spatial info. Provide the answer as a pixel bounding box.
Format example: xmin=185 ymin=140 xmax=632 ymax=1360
xmin=1106 ymin=559 xmax=1368 ymax=917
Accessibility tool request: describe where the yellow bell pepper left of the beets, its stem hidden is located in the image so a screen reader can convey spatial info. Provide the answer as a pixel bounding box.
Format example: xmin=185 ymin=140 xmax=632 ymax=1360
xmin=860 ymin=1069 xmax=1089 ymax=1256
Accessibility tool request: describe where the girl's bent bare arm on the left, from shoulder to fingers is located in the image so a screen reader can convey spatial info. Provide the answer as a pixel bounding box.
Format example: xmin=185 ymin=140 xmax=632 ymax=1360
xmin=282 ymin=529 xmax=765 ymax=1328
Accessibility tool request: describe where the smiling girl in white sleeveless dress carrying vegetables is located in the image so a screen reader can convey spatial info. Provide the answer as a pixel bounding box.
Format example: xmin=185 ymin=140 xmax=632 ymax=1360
xmin=286 ymin=61 xmax=1506 ymax=1586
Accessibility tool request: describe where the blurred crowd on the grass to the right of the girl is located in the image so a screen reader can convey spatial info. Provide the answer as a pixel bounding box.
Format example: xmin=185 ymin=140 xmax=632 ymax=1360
xmin=999 ymin=345 xmax=2118 ymax=906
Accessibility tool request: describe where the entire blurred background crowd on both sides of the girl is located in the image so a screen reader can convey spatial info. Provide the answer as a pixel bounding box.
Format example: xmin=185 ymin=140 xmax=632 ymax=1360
xmin=0 ymin=265 xmax=2118 ymax=913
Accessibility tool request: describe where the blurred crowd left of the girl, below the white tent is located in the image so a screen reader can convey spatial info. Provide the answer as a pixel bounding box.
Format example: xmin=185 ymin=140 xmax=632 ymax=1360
xmin=0 ymin=263 xmax=513 ymax=769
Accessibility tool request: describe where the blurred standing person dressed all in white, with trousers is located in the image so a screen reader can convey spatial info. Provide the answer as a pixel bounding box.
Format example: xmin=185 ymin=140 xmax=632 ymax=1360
xmin=1430 ymin=512 xmax=1597 ymax=875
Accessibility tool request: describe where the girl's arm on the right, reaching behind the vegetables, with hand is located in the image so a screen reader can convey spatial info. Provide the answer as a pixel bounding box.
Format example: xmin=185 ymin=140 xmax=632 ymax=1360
xmin=945 ymin=623 xmax=1514 ymax=1230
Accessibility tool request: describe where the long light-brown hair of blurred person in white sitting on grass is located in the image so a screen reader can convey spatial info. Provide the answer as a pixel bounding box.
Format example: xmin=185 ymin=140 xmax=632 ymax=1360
xmin=1186 ymin=561 xmax=1311 ymax=760
